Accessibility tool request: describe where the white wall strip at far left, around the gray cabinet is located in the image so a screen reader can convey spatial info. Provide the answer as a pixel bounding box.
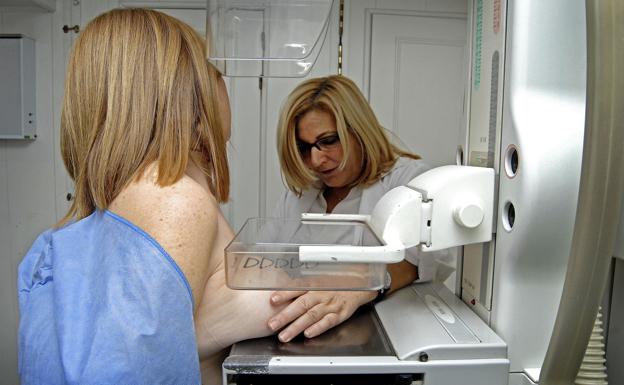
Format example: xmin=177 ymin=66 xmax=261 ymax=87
xmin=0 ymin=1 xmax=67 ymax=384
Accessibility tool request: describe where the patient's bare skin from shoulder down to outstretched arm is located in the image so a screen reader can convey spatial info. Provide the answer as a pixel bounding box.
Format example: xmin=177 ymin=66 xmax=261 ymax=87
xmin=109 ymin=163 xmax=281 ymax=366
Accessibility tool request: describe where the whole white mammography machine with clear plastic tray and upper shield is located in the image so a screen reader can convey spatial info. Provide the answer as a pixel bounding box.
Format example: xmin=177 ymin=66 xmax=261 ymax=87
xmin=208 ymin=0 xmax=624 ymax=385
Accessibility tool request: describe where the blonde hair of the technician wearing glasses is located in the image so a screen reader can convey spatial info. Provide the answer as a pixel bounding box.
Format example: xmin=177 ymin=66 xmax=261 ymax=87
xmin=277 ymin=75 xmax=420 ymax=195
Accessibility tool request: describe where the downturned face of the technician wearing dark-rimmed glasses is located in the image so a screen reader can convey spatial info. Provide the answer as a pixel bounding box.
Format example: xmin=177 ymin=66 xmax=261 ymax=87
xmin=297 ymin=110 xmax=362 ymax=188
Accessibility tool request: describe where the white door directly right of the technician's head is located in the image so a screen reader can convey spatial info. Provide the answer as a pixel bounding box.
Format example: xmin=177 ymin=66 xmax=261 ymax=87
xmin=369 ymin=13 xmax=467 ymax=166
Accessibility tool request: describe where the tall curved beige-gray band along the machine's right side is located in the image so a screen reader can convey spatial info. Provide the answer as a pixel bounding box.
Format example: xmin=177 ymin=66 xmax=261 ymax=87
xmin=540 ymin=0 xmax=624 ymax=385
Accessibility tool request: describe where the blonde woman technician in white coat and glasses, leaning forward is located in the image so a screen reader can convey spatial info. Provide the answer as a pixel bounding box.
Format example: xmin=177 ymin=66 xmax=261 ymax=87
xmin=268 ymin=76 xmax=434 ymax=342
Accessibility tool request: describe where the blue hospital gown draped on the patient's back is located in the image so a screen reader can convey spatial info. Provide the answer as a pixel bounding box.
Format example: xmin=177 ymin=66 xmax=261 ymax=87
xmin=18 ymin=211 xmax=201 ymax=385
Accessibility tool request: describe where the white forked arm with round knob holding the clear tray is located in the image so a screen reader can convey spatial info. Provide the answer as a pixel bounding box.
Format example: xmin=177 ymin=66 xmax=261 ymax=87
xmin=299 ymin=166 xmax=494 ymax=263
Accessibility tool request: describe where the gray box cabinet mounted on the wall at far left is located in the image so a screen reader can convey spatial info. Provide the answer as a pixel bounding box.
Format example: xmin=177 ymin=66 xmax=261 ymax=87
xmin=0 ymin=35 xmax=37 ymax=139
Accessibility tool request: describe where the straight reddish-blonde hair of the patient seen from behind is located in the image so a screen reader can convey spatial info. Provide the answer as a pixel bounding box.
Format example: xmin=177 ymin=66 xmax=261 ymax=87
xmin=60 ymin=9 xmax=229 ymax=224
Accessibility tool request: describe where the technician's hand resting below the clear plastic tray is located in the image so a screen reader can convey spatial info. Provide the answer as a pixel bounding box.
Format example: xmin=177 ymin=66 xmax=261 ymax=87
xmin=269 ymin=291 xmax=377 ymax=342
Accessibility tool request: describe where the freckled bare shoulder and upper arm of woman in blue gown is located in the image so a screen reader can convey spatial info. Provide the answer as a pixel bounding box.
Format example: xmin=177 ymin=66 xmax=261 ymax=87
xmin=109 ymin=168 xmax=219 ymax=307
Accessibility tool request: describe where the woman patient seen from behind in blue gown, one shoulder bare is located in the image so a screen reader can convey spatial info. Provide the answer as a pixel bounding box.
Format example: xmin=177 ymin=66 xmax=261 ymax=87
xmin=18 ymin=9 xmax=281 ymax=384
